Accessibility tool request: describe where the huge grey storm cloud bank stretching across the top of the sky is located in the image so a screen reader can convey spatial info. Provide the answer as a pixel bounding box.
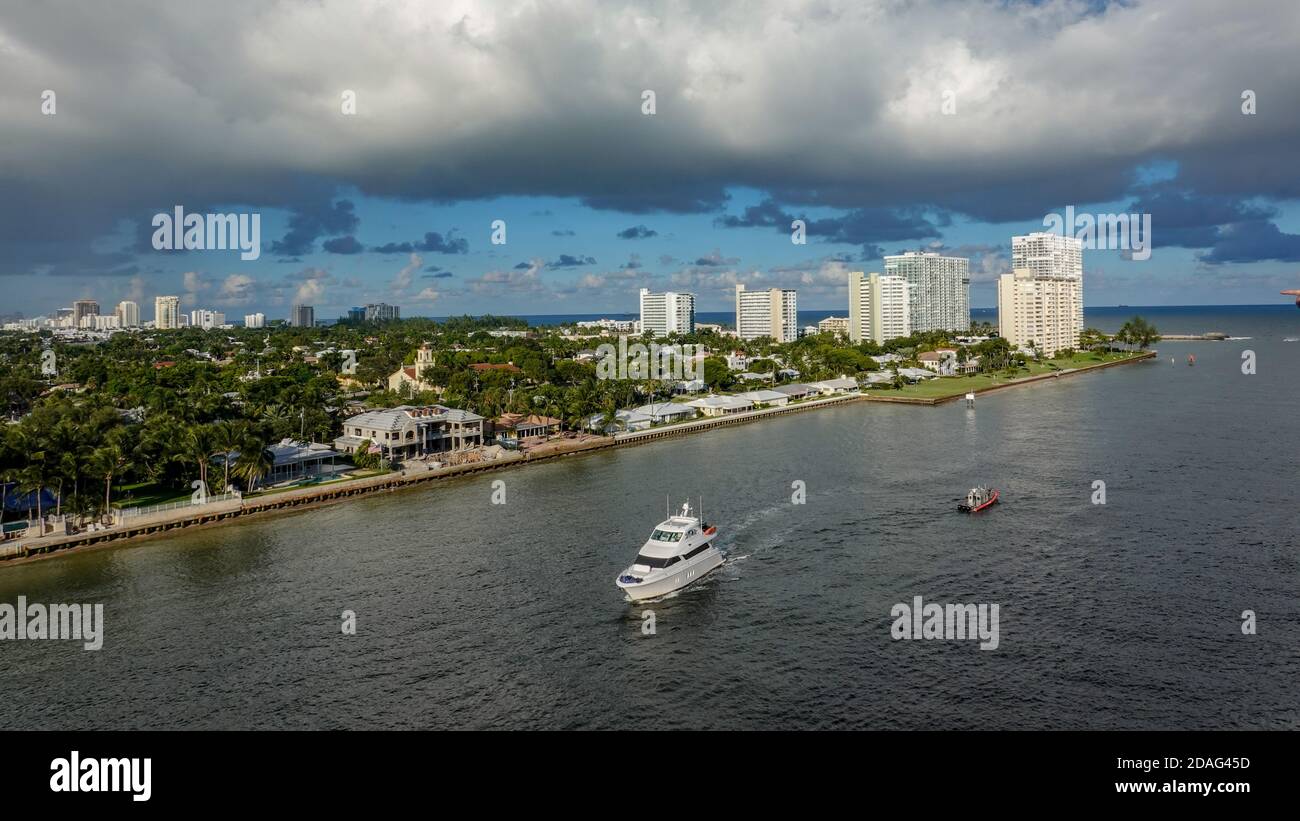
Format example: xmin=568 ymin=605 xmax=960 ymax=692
xmin=0 ymin=0 xmax=1300 ymax=281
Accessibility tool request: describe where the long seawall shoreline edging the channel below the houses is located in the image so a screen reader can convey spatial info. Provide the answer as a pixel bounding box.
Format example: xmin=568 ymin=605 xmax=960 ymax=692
xmin=0 ymin=351 xmax=1156 ymax=566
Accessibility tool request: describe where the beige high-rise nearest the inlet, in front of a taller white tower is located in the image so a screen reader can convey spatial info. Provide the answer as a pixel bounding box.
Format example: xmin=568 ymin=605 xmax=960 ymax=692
xmin=997 ymin=268 xmax=1083 ymax=356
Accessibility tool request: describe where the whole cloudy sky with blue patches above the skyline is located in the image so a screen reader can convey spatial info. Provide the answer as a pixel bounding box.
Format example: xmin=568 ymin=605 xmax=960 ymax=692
xmin=0 ymin=0 xmax=1300 ymax=318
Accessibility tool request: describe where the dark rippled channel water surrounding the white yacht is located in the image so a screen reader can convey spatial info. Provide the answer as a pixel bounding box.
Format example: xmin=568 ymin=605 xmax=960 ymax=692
xmin=0 ymin=308 xmax=1300 ymax=729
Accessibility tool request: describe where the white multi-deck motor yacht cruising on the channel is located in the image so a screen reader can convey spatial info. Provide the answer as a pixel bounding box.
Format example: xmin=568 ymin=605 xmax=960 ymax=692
xmin=616 ymin=501 xmax=723 ymax=601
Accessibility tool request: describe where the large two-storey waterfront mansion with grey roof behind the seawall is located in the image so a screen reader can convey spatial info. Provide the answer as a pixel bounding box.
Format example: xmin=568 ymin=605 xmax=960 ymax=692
xmin=334 ymin=405 xmax=484 ymax=459
